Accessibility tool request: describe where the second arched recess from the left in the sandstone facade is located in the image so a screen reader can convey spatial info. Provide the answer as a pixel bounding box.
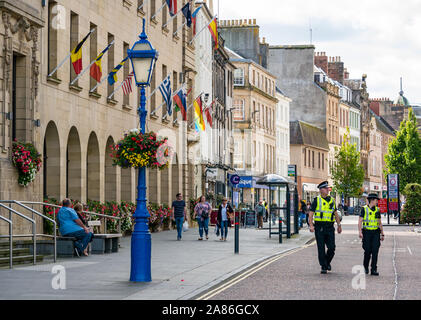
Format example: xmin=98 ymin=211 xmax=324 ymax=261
xmin=66 ymin=127 xmax=82 ymax=200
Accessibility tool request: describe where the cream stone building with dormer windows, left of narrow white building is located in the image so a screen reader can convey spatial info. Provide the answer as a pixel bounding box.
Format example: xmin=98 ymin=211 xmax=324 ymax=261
xmin=230 ymin=51 xmax=278 ymax=204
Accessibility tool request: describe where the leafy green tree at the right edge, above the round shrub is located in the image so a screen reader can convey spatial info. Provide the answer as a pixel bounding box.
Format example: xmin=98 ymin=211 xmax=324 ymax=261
xmin=384 ymin=108 xmax=421 ymax=190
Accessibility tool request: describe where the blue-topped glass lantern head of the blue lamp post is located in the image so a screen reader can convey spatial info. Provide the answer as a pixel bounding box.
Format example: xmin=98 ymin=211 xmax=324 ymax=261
xmin=127 ymin=19 xmax=158 ymax=86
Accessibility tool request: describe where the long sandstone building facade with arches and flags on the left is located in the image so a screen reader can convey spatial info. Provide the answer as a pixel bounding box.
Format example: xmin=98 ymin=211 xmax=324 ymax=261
xmin=0 ymin=0 xmax=220 ymax=235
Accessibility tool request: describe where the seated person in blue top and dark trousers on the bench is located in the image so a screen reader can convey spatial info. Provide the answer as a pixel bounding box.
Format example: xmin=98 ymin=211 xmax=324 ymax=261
xmin=57 ymin=199 xmax=93 ymax=257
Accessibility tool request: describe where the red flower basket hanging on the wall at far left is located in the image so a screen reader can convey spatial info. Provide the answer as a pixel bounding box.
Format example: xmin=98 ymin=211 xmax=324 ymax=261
xmin=12 ymin=141 xmax=42 ymax=187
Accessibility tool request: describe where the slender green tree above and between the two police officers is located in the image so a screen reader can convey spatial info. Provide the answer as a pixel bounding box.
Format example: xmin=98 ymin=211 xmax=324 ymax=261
xmin=331 ymin=129 xmax=364 ymax=198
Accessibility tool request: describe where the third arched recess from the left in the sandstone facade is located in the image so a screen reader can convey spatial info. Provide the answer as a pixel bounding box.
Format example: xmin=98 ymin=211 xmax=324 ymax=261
xmin=86 ymin=132 xmax=100 ymax=201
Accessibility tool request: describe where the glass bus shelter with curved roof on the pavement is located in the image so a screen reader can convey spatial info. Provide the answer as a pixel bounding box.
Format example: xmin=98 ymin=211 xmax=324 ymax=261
xmin=257 ymin=174 xmax=299 ymax=243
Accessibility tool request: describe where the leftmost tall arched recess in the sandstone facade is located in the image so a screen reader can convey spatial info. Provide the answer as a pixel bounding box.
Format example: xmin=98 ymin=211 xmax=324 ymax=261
xmin=43 ymin=121 xmax=61 ymax=200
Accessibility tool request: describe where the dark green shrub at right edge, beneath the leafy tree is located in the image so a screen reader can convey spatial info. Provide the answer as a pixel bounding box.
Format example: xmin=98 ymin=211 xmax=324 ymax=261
xmin=401 ymin=183 xmax=421 ymax=224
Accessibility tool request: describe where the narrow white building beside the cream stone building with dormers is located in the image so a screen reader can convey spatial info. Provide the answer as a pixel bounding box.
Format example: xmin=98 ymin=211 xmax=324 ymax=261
xmin=275 ymin=88 xmax=292 ymax=177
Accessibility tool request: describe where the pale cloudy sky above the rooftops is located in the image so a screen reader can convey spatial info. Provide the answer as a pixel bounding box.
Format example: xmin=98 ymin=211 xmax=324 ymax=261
xmin=218 ymin=0 xmax=421 ymax=105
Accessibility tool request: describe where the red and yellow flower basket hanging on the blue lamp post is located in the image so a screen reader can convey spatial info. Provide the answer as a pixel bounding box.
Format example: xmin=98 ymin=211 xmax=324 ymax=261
xmin=110 ymin=129 xmax=173 ymax=170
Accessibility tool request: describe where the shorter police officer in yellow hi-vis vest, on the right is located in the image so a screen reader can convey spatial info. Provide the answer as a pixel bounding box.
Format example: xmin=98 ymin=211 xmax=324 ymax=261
xmin=358 ymin=193 xmax=384 ymax=276
